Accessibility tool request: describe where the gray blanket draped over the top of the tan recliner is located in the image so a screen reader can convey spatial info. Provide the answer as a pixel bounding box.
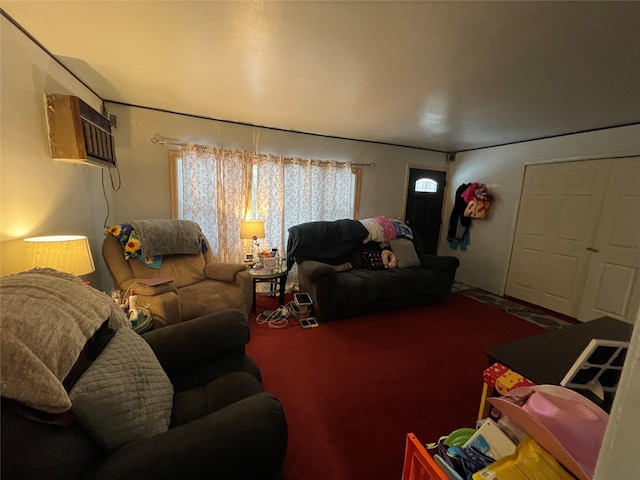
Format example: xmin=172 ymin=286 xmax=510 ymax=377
xmin=129 ymin=219 xmax=204 ymax=257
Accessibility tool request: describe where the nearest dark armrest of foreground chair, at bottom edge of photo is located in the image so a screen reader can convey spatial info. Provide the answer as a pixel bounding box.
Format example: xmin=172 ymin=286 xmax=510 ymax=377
xmin=87 ymin=393 xmax=287 ymax=480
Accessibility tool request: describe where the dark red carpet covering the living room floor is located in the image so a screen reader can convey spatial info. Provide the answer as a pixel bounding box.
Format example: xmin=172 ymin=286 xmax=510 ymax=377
xmin=247 ymin=294 xmax=544 ymax=480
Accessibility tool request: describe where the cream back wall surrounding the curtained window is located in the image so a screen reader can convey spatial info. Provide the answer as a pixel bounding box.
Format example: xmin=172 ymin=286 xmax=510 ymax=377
xmin=107 ymin=104 xmax=447 ymax=222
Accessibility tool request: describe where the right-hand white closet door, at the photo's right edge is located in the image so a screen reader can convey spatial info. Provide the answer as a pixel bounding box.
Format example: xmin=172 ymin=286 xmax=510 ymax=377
xmin=578 ymin=157 xmax=640 ymax=323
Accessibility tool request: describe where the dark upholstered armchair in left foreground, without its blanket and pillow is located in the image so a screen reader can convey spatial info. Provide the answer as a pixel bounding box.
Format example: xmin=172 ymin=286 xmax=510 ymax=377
xmin=0 ymin=287 xmax=287 ymax=480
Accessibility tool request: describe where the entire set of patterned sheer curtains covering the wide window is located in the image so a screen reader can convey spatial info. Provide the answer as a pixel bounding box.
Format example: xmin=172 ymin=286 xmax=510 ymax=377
xmin=178 ymin=144 xmax=355 ymax=268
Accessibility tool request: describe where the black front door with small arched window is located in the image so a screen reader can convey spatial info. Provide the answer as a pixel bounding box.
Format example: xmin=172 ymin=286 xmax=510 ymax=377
xmin=405 ymin=168 xmax=447 ymax=255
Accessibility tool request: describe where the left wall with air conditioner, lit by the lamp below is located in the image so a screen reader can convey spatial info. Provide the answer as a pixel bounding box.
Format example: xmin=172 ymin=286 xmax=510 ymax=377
xmin=0 ymin=17 xmax=111 ymax=288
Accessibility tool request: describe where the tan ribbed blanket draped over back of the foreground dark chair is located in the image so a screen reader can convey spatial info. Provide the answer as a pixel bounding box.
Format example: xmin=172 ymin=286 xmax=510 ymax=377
xmin=0 ymin=269 xmax=130 ymax=413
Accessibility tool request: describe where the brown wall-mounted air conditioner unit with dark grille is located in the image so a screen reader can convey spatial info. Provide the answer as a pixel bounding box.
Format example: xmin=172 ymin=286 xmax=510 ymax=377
xmin=45 ymin=93 xmax=116 ymax=167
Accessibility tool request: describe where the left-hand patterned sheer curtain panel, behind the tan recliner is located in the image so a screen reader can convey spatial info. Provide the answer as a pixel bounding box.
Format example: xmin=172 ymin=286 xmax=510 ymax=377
xmin=181 ymin=144 xmax=252 ymax=263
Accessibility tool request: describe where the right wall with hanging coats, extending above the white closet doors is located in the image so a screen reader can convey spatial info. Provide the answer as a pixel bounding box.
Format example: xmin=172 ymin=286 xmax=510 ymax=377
xmin=439 ymin=125 xmax=640 ymax=295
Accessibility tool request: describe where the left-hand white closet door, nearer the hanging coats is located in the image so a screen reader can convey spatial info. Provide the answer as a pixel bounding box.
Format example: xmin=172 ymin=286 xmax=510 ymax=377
xmin=506 ymin=160 xmax=611 ymax=317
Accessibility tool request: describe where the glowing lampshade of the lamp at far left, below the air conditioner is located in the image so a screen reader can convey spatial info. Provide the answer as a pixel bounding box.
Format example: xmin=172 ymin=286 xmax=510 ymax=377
xmin=24 ymin=235 xmax=96 ymax=276
